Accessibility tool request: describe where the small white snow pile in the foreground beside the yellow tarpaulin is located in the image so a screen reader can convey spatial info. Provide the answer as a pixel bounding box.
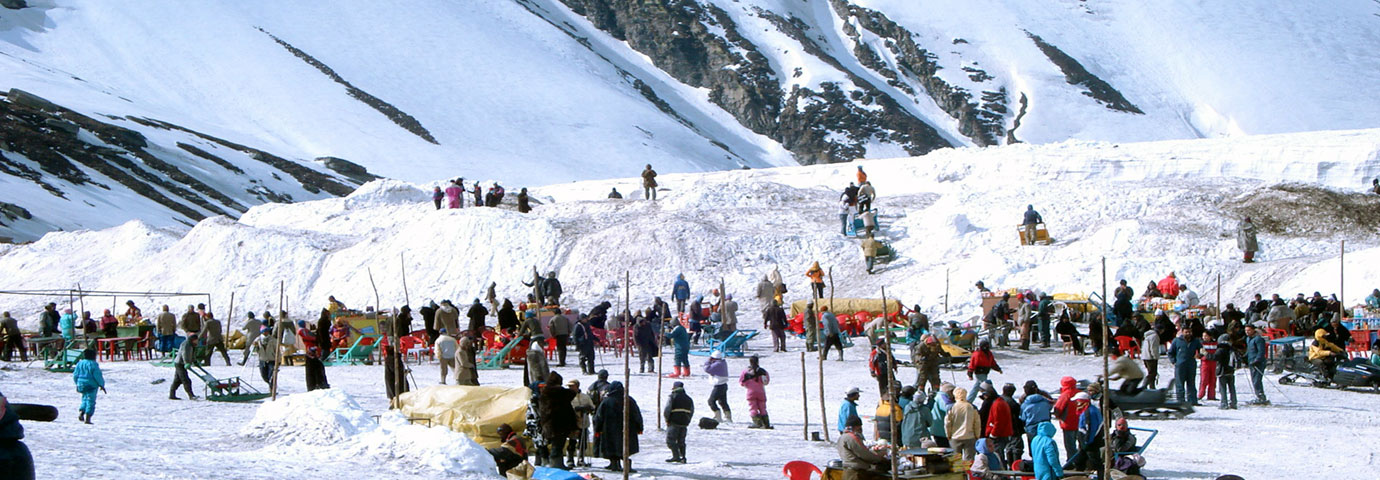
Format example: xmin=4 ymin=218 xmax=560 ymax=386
xmin=240 ymin=389 xmax=497 ymax=479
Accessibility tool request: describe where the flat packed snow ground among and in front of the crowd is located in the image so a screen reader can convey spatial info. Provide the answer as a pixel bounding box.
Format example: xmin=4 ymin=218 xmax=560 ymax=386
xmin=8 ymin=333 xmax=1380 ymax=480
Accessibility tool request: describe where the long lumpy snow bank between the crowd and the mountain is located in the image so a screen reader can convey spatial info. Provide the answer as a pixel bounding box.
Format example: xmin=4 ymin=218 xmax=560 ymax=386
xmin=0 ymin=130 xmax=1380 ymax=326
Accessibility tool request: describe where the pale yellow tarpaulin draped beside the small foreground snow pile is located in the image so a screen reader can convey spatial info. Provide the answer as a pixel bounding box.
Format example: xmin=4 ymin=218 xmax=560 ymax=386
xmin=402 ymin=385 xmax=531 ymax=448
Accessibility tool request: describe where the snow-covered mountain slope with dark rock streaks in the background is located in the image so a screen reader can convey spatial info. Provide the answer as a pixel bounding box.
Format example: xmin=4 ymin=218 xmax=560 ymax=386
xmin=0 ymin=0 xmax=1380 ymax=240
